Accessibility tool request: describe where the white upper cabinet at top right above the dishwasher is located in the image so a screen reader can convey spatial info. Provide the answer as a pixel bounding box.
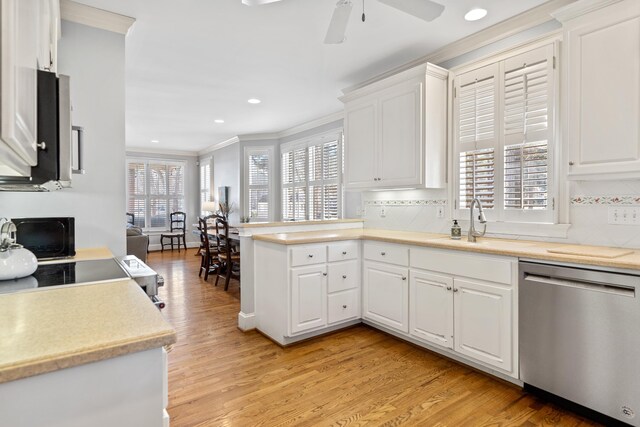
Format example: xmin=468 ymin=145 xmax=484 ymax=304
xmin=555 ymin=0 xmax=640 ymax=179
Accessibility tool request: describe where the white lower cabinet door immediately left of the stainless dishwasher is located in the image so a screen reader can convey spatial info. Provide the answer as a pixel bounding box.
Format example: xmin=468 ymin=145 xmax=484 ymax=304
xmin=453 ymin=279 xmax=513 ymax=372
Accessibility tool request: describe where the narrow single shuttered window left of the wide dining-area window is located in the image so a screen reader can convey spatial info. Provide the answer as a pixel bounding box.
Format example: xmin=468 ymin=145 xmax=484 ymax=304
xmin=244 ymin=147 xmax=273 ymax=221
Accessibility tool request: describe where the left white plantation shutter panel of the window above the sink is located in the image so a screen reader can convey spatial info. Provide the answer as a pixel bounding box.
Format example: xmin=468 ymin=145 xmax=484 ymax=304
xmin=454 ymin=64 xmax=499 ymax=209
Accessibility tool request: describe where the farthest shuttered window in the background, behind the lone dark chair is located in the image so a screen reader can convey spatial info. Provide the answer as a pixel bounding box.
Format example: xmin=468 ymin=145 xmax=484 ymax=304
xmin=127 ymin=158 xmax=185 ymax=230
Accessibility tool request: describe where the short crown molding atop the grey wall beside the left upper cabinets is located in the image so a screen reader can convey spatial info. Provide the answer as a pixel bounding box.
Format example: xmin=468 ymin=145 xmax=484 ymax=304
xmin=60 ymin=0 xmax=136 ymax=36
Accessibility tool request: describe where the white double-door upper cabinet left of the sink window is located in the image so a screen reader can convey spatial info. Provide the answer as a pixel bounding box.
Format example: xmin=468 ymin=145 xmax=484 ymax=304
xmin=341 ymin=64 xmax=449 ymax=189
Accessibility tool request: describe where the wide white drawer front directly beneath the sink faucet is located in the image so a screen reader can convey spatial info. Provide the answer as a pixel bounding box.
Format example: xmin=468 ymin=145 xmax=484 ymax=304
xmin=411 ymin=248 xmax=513 ymax=285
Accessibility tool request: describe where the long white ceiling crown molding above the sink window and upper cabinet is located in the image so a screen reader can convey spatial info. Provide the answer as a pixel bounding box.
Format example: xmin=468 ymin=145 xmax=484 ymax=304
xmin=342 ymin=0 xmax=576 ymax=95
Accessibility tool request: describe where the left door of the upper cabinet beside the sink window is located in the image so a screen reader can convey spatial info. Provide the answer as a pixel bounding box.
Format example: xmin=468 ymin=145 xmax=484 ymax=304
xmin=345 ymin=100 xmax=378 ymax=188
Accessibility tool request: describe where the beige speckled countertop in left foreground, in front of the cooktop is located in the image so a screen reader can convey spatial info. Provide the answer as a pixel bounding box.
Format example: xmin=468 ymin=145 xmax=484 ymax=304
xmin=0 ymin=279 xmax=176 ymax=383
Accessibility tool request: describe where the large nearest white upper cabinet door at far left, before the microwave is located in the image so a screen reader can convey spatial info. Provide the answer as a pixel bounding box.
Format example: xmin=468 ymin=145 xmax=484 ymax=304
xmin=0 ymin=0 xmax=40 ymax=166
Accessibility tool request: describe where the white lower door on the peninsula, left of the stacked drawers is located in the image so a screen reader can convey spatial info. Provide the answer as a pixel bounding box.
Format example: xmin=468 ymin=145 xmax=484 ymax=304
xmin=291 ymin=264 xmax=327 ymax=334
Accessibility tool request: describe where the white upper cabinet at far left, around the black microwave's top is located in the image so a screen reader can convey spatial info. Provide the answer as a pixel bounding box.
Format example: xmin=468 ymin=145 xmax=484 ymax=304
xmin=0 ymin=0 xmax=60 ymax=176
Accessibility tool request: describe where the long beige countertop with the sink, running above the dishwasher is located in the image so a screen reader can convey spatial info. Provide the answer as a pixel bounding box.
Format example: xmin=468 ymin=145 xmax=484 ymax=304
xmin=253 ymin=228 xmax=640 ymax=270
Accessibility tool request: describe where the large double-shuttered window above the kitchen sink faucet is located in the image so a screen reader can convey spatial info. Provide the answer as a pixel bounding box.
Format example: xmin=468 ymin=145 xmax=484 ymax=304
xmin=454 ymin=44 xmax=557 ymax=223
